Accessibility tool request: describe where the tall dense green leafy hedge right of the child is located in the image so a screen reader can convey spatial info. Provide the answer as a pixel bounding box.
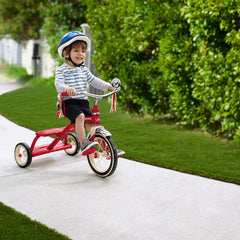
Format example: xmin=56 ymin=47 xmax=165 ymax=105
xmin=86 ymin=0 xmax=240 ymax=138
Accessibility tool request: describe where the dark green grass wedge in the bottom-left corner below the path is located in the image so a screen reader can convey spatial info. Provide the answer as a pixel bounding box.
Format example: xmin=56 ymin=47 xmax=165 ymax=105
xmin=0 ymin=202 xmax=70 ymax=240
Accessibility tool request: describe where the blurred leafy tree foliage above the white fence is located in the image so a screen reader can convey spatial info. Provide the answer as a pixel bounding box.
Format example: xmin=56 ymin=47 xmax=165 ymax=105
xmin=0 ymin=0 xmax=86 ymax=62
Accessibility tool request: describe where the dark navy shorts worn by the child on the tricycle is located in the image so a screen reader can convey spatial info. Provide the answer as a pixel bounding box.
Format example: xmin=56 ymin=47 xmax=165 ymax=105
xmin=62 ymin=99 xmax=93 ymax=123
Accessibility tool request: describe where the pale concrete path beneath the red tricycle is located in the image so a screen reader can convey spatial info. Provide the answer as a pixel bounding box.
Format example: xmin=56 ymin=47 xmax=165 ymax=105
xmin=0 ymin=78 xmax=240 ymax=240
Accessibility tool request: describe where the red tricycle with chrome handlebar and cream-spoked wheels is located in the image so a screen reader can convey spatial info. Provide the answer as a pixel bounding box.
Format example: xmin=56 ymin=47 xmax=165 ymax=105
xmin=14 ymin=88 xmax=124 ymax=177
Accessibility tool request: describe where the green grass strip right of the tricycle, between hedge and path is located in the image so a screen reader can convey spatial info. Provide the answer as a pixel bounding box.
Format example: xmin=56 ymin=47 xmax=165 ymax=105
xmin=104 ymin=109 xmax=240 ymax=184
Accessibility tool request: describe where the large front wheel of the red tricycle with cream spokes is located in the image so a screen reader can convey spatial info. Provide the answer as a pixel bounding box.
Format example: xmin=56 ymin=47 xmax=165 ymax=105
xmin=87 ymin=133 xmax=118 ymax=177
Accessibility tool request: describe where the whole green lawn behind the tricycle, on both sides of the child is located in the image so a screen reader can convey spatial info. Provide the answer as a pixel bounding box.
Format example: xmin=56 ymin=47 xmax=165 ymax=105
xmin=0 ymin=85 xmax=240 ymax=184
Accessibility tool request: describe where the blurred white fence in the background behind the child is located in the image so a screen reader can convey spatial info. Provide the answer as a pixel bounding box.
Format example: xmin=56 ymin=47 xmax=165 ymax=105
xmin=0 ymin=24 xmax=93 ymax=77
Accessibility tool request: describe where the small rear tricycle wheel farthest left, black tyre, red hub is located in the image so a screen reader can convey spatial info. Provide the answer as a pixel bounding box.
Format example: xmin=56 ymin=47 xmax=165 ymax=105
xmin=14 ymin=143 xmax=32 ymax=168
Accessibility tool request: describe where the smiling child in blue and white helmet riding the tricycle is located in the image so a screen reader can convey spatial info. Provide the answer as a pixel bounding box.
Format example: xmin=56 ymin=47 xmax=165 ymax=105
xmin=55 ymin=31 xmax=114 ymax=154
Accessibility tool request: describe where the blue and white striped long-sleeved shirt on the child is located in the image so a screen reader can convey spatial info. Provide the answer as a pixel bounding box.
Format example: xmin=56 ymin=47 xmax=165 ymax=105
xmin=55 ymin=63 xmax=110 ymax=102
